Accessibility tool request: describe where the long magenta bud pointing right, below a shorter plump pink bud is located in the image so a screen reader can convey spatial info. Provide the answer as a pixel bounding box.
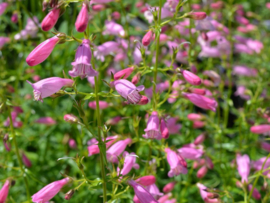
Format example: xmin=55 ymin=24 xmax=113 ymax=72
xmin=182 ymin=92 xmax=218 ymax=111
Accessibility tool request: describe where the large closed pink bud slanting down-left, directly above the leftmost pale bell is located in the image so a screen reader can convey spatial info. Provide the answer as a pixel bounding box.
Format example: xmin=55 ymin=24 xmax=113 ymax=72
xmin=26 ymin=36 xmax=60 ymax=66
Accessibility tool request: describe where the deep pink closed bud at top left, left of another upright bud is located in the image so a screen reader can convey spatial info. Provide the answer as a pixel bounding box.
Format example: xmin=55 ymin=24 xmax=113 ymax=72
xmin=41 ymin=8 xmax=61 ymax=32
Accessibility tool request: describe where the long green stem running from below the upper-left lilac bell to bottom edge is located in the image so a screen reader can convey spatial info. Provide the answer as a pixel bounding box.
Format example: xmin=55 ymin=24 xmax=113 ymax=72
xmin=92 ymin=63 xmax=107 ymax=203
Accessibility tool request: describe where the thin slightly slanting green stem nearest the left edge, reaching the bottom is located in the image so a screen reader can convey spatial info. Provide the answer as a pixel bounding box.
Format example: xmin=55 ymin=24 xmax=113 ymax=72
xmin=9 ymin=109 xmax=30 ymax=202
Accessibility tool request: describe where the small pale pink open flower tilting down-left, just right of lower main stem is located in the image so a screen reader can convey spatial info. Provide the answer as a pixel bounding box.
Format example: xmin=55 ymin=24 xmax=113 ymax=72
xmin=117 ymin=151 xmax=140 ymax=176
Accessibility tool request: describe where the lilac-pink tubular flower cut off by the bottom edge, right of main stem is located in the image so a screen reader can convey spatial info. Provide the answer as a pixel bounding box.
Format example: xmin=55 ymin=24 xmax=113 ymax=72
xmin=128 ymin=180 xmax=158 ymax=203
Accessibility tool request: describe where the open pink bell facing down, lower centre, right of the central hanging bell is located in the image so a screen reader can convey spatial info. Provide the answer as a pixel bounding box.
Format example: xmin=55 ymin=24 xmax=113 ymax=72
xmin=165 ymin=148 xmax=187 ymax=178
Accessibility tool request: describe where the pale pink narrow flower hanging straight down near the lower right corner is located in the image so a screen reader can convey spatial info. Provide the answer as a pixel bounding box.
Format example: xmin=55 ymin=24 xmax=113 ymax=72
xmin=236 ymin=154 xmax=250 ymax=183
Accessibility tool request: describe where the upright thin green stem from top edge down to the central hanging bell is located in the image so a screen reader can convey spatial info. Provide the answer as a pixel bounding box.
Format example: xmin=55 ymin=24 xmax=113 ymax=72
xmin=153 ymin=0 xmax=162 ymax=111
